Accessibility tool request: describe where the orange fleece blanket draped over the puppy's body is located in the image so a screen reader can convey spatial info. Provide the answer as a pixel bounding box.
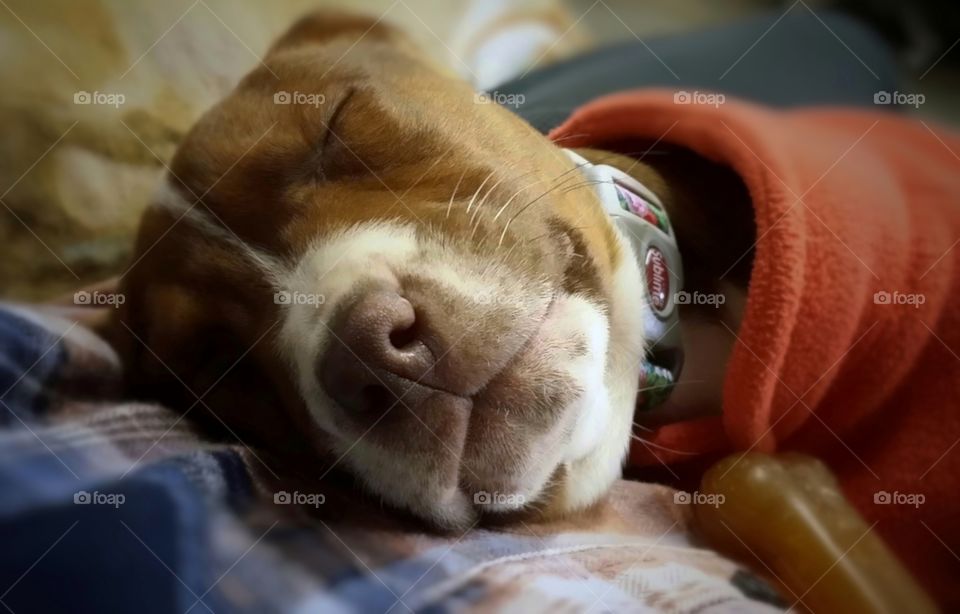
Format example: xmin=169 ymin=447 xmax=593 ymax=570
xmin=551 ymin=90 xmax=960 ymax=605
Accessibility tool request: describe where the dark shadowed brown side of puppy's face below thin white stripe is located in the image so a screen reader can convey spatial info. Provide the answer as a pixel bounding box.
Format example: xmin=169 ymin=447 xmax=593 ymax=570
xmin=107 ymin=209 xmax=310 ymax=447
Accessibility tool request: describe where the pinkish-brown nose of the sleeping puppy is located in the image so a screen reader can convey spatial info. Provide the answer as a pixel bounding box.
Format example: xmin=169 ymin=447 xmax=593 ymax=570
xmin=318 ymin=290 xmax=437 ymax=415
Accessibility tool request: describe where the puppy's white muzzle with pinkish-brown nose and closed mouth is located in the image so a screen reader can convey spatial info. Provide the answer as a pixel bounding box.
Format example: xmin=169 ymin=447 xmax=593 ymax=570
xmin=285 ymin=223 xmax=624 ymax=528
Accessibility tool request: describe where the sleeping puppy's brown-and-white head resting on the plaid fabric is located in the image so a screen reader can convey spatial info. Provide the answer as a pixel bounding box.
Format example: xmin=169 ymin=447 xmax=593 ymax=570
xmin=120 ymin=10 xmax=646 ymax=527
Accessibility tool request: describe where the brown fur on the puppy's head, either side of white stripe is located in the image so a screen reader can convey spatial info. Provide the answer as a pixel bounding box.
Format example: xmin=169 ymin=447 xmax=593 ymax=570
xmin=112 ymin=13 xmax=621 ymax=476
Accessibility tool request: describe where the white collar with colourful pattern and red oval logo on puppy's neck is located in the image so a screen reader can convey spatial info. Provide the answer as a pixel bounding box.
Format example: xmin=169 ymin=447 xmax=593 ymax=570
xmin=564 ymin=149 xmax=683 ymax=411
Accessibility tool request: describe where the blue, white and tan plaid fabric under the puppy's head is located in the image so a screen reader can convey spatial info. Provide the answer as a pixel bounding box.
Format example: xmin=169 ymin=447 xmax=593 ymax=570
xmin=0 ymin=306 xmax=782 ymax=614
